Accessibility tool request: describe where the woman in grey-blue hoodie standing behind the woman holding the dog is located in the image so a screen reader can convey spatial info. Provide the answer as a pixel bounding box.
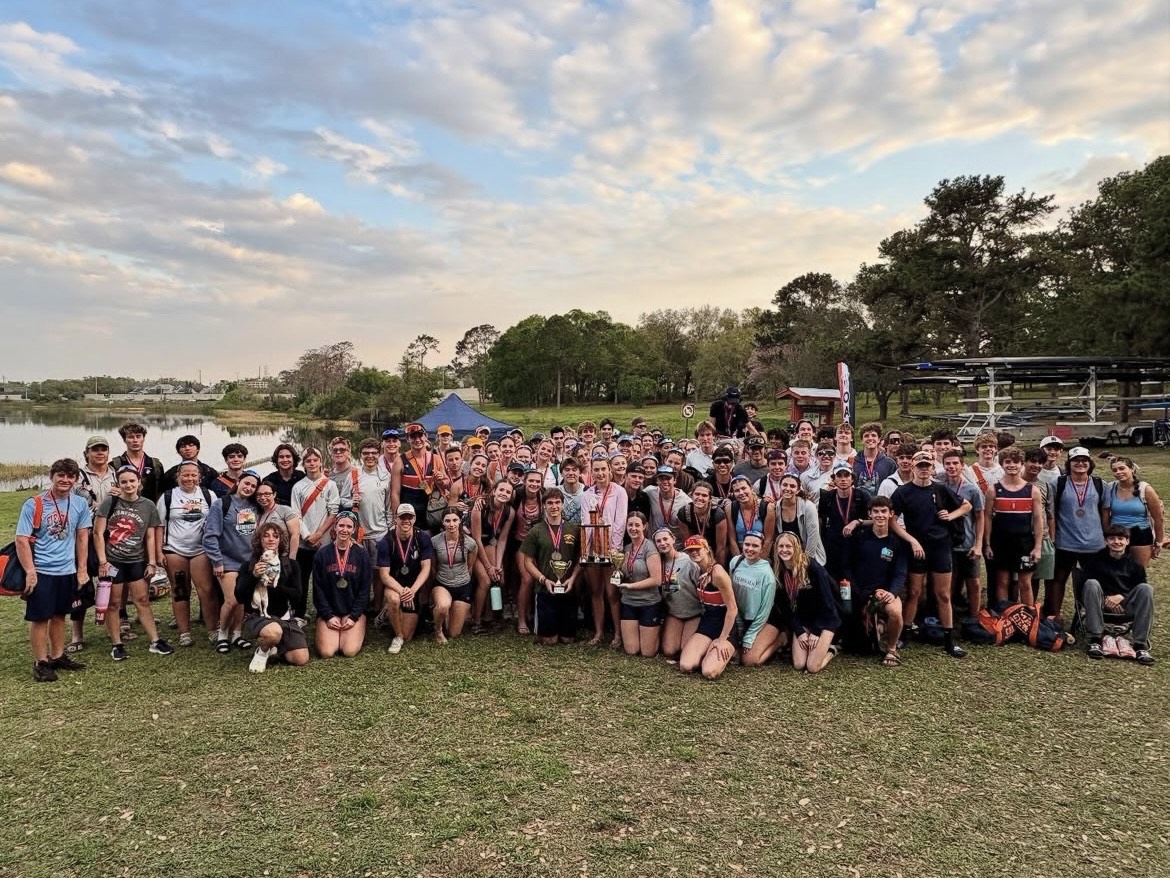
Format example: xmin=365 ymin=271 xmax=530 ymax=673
xmin=204 ymin=469 xmax=260 ymax=654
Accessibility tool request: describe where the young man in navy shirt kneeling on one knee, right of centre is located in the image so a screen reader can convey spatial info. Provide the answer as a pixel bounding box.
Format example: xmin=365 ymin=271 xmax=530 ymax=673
xmin=848 ymin=496 xmax=910 ymax=667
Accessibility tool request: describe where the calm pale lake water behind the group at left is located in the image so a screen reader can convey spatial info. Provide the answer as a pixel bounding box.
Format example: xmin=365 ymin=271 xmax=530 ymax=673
xmin=0 ymin=409 xmax=341 ymax=491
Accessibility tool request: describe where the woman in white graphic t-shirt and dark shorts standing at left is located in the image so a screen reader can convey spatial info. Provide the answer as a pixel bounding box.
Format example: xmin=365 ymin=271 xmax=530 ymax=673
xmin=154 ymin=460 xmax=220 ymax=646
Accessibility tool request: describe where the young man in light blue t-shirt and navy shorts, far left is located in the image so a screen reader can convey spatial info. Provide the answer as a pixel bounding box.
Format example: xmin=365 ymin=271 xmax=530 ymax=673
xmin=16 ymin=458 xmax=94 ymax=682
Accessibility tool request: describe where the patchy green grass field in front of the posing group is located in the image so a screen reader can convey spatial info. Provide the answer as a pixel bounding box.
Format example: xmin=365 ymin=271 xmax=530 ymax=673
xmin=0 ymin=454 xmax=1170 ymax=878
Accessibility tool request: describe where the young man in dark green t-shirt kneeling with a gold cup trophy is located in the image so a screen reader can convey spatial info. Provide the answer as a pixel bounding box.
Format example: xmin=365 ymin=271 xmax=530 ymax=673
xmin=519 ymin=488 xmax=580 ymax=646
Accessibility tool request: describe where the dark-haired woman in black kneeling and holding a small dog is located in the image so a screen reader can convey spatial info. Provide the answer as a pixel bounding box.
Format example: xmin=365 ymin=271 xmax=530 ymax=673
xmin=235 ymin=521 xmax=309 ymax=674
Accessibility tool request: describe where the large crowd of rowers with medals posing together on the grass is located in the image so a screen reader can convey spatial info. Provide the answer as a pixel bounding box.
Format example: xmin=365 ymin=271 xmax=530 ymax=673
xmin=9 ymin=389 xmax=1165 ymax=681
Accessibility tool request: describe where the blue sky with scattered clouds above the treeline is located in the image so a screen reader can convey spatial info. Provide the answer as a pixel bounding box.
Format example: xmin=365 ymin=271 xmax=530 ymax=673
xmin=0 ymin=0 xmax=1170 ymax=380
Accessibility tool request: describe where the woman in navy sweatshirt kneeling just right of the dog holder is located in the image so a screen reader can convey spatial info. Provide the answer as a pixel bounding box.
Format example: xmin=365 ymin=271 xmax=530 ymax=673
xmin=312 ymin=509 xmax=373 ymax=658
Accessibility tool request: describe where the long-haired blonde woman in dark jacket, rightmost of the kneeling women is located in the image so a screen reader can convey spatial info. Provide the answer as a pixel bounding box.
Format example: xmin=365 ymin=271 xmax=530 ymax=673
xmin=776 ymin=534 xmax=841 ymax=674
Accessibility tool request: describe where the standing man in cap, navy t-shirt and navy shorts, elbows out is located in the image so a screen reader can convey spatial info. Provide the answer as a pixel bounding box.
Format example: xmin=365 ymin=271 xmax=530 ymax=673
xmin=890 ymin=451 xmax=971 ymax=658
